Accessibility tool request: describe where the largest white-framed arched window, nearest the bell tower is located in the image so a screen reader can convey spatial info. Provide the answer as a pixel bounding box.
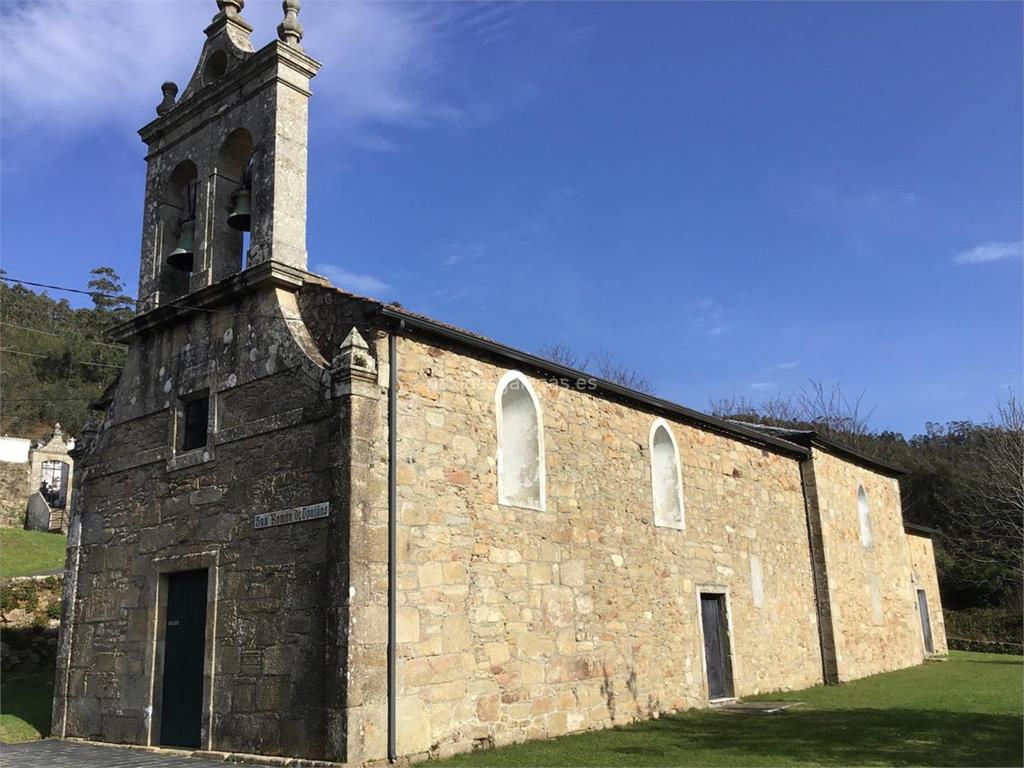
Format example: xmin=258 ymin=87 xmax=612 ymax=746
xmin=495 ymin=371 xmax=545 ymax=510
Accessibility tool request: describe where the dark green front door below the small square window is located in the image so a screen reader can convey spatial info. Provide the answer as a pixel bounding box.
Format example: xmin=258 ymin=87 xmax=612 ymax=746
xmin=160 ymin=569 xmax=208 ymax=748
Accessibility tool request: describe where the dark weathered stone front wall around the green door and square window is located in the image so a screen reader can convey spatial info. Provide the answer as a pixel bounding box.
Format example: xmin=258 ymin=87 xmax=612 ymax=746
xmin=54 ymin=291 xmax=347 ymax=758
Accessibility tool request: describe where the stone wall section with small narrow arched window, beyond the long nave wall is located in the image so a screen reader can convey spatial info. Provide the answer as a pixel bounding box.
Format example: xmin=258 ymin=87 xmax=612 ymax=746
xmin=813 ymin=447 xmax=924 ymax=681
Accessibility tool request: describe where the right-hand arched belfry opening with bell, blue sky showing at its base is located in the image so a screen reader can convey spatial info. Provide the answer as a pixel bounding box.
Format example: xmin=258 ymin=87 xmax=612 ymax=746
xmin=209 ymin=128 xmax=254 ymax=281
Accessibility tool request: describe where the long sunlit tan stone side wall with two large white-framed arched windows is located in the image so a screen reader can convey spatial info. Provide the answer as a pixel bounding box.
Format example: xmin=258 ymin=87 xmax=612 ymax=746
xmin=385 ymin=337 xmax=821 ymax=755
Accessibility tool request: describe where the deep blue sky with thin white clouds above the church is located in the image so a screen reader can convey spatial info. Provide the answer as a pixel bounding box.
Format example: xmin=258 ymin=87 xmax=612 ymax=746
xmin=0 ymin=0 xmax=1024 ymax=434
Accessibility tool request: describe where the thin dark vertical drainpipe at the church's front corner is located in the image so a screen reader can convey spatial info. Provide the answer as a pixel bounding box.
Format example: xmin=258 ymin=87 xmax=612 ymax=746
xmin=387 ymin=321 xmax=406 ymax=763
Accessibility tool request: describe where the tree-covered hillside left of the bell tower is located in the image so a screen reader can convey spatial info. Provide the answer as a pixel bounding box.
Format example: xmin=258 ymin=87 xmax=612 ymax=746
xmin=0 ymin=266 xmax=134 ymax=437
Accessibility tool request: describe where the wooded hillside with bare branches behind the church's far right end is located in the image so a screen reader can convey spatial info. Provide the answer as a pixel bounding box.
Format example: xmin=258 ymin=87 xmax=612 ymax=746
xmin=711 ymin=382 xmax=1024 ymax=652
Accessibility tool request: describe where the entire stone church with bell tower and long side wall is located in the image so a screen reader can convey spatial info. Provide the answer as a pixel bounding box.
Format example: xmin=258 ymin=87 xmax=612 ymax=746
xmin=53 ymin=0 xmax=945 ymax=764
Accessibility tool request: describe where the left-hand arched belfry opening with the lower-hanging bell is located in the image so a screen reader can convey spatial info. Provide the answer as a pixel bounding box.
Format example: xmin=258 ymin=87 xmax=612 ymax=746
xmin=157 ymin=160 xmax=199 ymax=298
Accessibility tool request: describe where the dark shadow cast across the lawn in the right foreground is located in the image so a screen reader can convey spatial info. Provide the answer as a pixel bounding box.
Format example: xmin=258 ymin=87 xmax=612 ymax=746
xmin=439 ymin=708 xmax=1024 ymax=766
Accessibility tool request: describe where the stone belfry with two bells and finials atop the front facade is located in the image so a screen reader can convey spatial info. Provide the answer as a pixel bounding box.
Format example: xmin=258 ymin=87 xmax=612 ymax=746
xmin=138 ymin=0 xmax=319 ymax=312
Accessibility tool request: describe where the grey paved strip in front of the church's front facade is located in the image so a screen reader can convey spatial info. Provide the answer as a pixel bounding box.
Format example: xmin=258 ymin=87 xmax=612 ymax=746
xmin=0 ymin=739 xmax=231 ymax=768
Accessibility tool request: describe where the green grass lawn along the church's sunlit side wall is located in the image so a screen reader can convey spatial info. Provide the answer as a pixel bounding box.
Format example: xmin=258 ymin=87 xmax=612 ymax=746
xmin=432 ymin=651 xmax=1024 ymax=768
